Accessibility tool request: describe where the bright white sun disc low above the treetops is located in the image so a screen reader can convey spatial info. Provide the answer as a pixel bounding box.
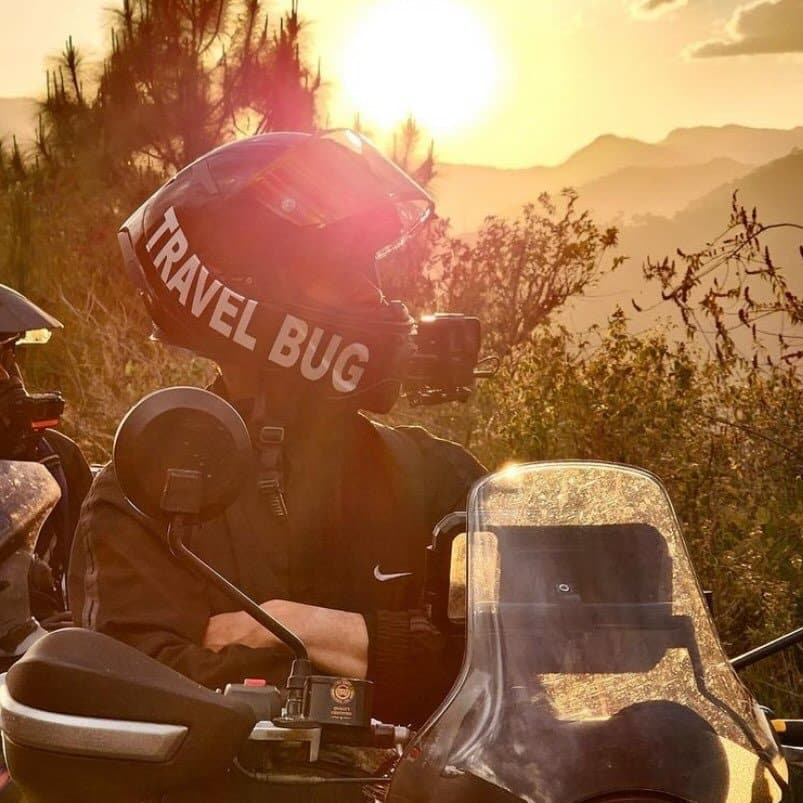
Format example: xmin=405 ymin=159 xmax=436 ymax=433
xmin=339 ymin=0 xmax=499 ymax=136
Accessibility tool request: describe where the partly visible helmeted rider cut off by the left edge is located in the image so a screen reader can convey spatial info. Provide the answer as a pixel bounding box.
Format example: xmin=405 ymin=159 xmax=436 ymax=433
xmin=0 ymin=285 xmax=92 ymax=619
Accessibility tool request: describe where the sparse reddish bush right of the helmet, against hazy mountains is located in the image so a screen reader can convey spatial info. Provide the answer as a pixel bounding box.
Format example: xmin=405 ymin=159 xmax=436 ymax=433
xmin=386 ymin=190 xmax=624 ymax=354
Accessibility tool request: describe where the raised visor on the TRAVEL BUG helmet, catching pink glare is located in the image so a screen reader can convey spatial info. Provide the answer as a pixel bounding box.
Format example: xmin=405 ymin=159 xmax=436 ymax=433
xmin=246 ymin=129 xmax=435 ymax=259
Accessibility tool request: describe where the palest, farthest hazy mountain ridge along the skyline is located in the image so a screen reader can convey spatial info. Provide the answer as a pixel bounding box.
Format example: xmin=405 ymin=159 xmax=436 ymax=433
xmin=432 ymin=126 xmax=803 ymax=232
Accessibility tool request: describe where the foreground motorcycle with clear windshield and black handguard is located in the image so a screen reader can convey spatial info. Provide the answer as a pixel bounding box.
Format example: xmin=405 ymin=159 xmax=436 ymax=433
xmin=0 ymin=398 xmax=789 ymax=803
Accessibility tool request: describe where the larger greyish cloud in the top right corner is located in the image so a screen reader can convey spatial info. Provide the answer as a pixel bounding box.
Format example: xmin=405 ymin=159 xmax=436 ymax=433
xmin=689 ymin=0 xmax=803 ymax=59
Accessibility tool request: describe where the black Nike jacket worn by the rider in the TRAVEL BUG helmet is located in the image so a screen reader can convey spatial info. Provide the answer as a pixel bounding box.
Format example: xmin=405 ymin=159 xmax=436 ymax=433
xmin=70 ymin=415 xmax=484 ymax=722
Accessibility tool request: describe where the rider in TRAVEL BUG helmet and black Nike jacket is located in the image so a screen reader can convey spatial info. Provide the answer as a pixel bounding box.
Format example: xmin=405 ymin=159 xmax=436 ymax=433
xmin=70 ymin=132 xmax=483 ymax=722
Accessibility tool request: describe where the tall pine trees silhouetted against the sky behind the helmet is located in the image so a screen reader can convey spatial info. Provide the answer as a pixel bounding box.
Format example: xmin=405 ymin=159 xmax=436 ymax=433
xmin=38 ymin=0 xmax=321 ymax=172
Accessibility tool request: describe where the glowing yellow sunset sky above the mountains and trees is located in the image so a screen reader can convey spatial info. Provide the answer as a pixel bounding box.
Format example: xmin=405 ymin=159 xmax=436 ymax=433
xmin=0 ymin=0 xmax=803 ymax=167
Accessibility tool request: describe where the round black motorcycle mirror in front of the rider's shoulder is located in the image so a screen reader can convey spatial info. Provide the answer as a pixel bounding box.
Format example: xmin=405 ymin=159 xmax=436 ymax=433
xmin=112 ymin=387 xmax=252 ymax=521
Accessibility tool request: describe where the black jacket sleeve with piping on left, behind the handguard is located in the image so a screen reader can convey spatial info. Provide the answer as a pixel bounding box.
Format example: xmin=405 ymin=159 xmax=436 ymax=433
xmin=69 ymin=466 xmax=290 ymax=688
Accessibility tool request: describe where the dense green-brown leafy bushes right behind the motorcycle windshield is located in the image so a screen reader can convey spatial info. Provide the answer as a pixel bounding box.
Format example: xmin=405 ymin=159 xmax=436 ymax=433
xmin=490 ymin=312 xmax=803 ymax=715
